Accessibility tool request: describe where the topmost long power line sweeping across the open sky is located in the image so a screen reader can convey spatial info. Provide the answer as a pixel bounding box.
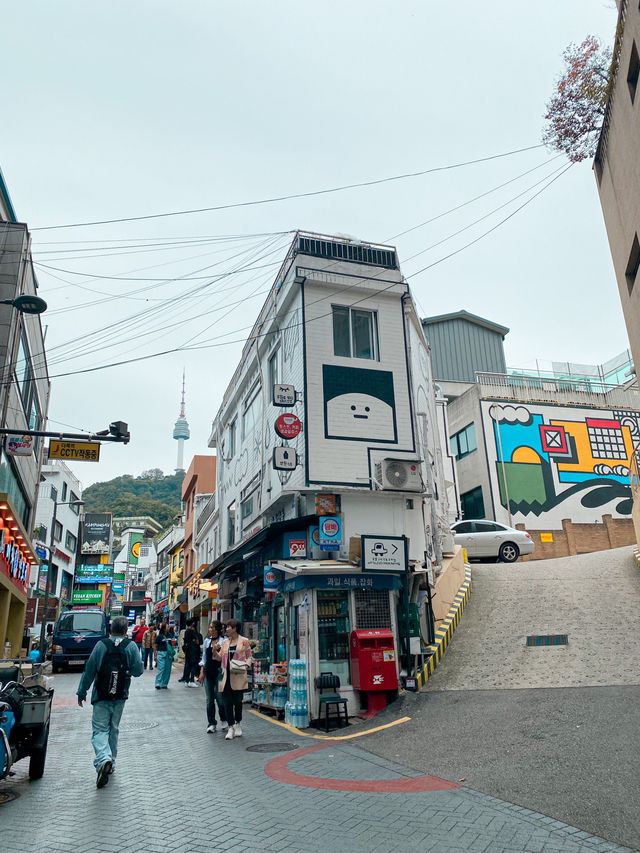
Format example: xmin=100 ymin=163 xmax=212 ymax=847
xmin=30 ymin=144 xmax=545 ymax=231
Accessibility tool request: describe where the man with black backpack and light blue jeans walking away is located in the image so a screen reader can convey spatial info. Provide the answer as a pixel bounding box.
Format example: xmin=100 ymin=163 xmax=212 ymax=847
xmin=77 ymin=616 xmax=142 ymax=788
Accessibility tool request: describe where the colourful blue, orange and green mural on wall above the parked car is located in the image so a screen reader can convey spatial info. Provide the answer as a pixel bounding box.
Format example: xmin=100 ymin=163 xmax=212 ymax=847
xmin=482 ymin=401 xmax=640 ymax=522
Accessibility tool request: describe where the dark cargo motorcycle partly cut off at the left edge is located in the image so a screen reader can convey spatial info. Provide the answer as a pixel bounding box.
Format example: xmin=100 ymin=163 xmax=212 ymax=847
xmin=0 ymin=658 xmax=53 ymax=779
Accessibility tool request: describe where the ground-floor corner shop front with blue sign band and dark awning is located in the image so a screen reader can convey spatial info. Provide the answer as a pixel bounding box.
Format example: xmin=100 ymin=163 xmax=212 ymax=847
xmin=202 ymin=516 xmax=403 ymax=719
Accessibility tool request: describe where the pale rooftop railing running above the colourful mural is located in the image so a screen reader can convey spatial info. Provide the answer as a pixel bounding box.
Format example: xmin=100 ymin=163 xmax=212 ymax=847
xmin=476 ymin=371 xmax=640 ymax=410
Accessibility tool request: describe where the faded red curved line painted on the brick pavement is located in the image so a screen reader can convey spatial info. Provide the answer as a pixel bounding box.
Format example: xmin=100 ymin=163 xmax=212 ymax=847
xmin=264 ymin=743 xmax=460 ymax=794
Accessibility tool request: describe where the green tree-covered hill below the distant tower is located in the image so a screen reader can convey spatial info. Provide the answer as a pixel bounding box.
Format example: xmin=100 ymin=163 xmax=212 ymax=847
xmin=82 ymin=468 xmax=184 ymax=527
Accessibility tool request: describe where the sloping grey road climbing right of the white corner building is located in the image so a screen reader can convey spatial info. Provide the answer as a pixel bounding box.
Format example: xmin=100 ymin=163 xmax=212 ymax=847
xmin=364 ymin=548 xmax=640 ymax=849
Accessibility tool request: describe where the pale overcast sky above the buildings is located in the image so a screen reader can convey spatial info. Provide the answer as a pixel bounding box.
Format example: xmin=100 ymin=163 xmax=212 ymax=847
xmin=0 ymin=0 xmax=628 ymax=486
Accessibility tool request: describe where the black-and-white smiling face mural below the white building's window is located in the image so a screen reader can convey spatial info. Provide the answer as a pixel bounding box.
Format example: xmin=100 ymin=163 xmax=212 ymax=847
xmin=322 ymin=364 xmax=397 ymax=442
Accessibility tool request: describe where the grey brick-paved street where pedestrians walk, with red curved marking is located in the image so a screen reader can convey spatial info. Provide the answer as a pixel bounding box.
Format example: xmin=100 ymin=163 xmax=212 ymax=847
xmin=0 ymin=660 xmax=632 ymax=853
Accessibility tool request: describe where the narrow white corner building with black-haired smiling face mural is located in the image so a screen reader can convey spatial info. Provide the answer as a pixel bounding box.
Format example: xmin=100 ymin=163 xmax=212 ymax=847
xmin=203 ymin=232 xmax=455 ymax=715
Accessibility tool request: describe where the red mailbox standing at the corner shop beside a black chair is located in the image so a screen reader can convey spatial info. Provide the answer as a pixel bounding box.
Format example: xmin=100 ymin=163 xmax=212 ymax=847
xmin=351 ymin=628 xmax=398 ymax=716
